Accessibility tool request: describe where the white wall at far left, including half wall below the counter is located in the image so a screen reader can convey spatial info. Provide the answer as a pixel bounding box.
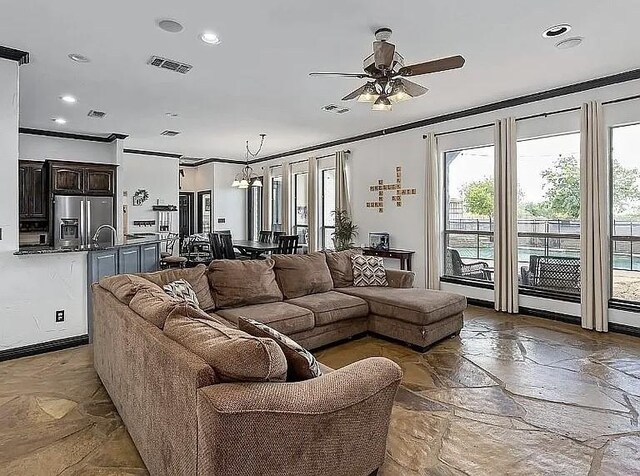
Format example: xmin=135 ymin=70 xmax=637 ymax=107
xmin=0 ymin=60 xmax=87 ymax=350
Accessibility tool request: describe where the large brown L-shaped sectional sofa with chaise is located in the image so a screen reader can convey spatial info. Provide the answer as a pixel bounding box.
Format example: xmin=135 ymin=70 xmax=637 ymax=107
xmin=92 ymin=252 xmax=466 ymax=476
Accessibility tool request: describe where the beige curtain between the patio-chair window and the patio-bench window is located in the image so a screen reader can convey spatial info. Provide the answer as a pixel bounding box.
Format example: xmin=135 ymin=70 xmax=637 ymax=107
xmin=494 ymin=117 xmax=518 ymax=313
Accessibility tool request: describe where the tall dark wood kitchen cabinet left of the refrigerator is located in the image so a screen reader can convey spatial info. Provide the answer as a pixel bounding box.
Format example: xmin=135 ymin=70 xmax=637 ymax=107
xmin=18 ymin=160 xmax=49 ymax=220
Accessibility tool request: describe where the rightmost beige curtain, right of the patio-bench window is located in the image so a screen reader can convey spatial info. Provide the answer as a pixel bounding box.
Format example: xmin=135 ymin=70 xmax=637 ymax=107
xmin=580 ymin=101 xmax=609 ymax=332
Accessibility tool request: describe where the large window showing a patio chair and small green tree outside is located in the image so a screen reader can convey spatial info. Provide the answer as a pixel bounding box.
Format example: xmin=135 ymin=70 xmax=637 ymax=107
xmin=444 ymin=146 xmax=494 ymax=284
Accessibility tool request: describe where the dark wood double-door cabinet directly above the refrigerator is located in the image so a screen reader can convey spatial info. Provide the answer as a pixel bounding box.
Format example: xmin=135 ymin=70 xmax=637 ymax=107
xmin=49 ymin=162 xmax=116 ymax=196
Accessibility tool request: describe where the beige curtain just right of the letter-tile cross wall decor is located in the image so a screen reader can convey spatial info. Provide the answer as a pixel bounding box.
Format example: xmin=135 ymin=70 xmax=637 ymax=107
xmin=424 ymin=132 xmax=441 ymax=289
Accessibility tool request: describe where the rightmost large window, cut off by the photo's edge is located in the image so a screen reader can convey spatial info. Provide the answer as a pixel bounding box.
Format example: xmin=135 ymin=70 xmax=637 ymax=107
xmin=610 ymin=124 xmax=640 ymax=302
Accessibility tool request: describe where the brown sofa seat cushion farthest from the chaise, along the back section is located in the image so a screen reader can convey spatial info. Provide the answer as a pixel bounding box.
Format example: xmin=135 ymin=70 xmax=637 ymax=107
xmin=217 ymin=302 xmax=314 ymax=335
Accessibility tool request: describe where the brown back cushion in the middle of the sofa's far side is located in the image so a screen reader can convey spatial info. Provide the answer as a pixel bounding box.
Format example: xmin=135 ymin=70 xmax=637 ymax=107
xmin=273 ymin=252 xmax=333 ymax=299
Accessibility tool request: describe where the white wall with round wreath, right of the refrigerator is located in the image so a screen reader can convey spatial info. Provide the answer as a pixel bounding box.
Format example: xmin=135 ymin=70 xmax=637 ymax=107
xmin=118 ymin=153 xmax=179 ymax=233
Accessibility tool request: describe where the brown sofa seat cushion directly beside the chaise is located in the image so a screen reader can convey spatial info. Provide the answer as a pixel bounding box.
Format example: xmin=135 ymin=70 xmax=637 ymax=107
xmin=286 ymin=291 xmax=369 ymax=332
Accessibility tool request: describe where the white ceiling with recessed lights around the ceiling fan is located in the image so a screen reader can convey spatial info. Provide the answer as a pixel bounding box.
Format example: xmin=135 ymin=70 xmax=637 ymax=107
xmin=0 ymin=0 xmax=640 ymax=159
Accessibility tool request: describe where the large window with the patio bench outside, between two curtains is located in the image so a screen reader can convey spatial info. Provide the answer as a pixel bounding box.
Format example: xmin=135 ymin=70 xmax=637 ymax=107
xmin=518 ymin=133 xmax=580 ymax=299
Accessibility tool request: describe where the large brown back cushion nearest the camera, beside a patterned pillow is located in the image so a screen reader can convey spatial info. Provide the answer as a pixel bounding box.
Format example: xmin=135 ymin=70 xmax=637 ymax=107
xmin=164 ymin=304 xmax=287 ymax=382
